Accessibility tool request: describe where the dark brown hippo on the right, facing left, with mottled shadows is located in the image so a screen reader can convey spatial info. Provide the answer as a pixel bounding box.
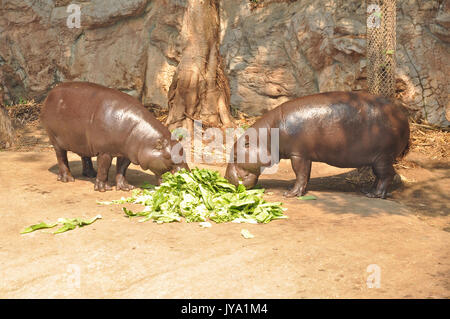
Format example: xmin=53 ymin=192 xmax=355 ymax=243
xmin=225 ymin=91 xmax=409 ymax=198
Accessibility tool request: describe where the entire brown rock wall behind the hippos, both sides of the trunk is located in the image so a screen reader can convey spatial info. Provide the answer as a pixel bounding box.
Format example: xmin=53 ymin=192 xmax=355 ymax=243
xmin=0 ymin=0 xmax=450 ymax=126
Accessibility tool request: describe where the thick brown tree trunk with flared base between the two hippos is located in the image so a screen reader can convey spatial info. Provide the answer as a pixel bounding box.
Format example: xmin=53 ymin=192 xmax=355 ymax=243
xmin=166 ymin=0 xmax=233 ymax=132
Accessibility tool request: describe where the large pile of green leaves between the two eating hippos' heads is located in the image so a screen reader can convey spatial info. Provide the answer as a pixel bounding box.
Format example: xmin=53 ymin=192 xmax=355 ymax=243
xmin=99 ymin=168 xmax=287 ymax=223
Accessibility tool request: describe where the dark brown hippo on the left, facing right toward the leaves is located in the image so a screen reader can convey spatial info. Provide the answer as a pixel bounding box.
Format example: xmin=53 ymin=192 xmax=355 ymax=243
xmin=41 ymin=82 xmax=188 ymax=192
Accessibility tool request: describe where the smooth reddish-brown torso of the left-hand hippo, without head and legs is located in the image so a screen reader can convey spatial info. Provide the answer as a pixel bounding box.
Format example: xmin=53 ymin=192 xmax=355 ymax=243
xmin=41 ymin=82 xmax=170 ymax=162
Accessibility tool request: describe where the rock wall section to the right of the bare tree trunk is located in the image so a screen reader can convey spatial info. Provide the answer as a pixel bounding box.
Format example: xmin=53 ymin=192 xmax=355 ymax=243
xmin=222 ymin=0 xmax=450 ymax=126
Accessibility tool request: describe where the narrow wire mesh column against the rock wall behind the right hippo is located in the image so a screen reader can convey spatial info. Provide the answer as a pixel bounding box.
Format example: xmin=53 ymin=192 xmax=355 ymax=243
xmin=367 ymin=0 xmax=396 ymax=97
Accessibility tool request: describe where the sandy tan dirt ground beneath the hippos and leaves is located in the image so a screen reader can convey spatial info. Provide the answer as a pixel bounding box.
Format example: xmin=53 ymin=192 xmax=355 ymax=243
xmin=0 ymin=124 xmax=450 ymax=298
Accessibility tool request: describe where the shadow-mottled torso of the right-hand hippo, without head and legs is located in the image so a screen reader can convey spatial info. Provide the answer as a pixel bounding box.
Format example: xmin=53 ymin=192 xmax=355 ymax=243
xmin=253 ymin=92 xmax=409 ymax=167
